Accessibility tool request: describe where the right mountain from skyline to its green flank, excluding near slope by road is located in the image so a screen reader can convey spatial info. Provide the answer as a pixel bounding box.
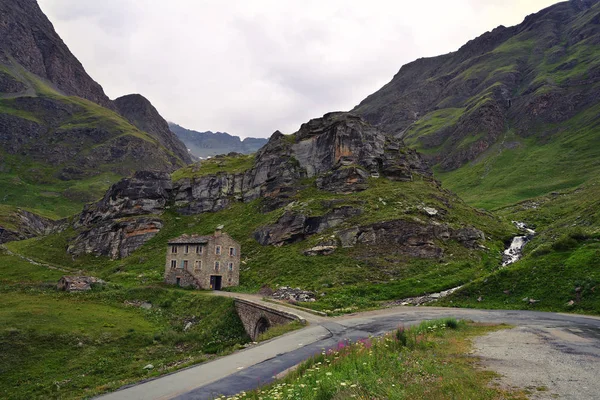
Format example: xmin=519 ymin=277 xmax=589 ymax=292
xmin=353 ymin=0 xmax=600 ymax=208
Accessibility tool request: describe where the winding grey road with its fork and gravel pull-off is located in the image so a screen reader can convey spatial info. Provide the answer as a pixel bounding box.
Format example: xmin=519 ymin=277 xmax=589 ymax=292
xmin=99 ymin=293 xmax=600 ymax=400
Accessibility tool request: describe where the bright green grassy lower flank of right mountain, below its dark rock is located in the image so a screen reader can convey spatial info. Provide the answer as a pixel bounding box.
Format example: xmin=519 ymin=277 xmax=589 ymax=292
xmin=436 ymin=107 xmax=600 ymax=209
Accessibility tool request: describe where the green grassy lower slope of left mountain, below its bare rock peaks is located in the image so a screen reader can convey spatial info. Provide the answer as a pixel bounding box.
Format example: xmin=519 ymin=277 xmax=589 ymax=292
xmin=0 ymin=64 xmax=183 ymax=218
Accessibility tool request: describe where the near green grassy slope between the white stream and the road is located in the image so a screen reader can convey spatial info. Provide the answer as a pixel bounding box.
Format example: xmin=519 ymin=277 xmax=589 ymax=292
xmin=446 ymin=183 xmax=600 ymax=314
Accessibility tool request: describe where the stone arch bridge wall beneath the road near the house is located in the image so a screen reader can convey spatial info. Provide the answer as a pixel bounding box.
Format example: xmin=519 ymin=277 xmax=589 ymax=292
xmin=235 ymin=299 xmax=306 ymax=340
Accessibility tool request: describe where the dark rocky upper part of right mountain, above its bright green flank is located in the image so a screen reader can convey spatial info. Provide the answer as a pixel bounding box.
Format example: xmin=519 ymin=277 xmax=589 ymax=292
xmin=352 ymin=0 xmax=600 ymax=170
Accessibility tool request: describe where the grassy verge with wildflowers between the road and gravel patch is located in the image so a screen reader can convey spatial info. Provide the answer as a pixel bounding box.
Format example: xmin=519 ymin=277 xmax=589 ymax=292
xmin=223 ymin=319 xmax=525 ymax=400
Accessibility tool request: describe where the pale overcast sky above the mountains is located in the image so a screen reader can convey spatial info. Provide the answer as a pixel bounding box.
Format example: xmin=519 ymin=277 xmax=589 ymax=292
xmin=38 ymin=0 xmax=557 ymax=137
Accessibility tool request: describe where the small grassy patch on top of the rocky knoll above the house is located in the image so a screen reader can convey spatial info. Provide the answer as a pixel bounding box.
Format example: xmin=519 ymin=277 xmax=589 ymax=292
xmin=172 ymin=154 xmax=254 ymax=182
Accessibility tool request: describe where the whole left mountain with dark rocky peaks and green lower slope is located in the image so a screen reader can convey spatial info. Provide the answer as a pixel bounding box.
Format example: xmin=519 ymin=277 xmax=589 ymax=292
xmin=0 ymin=0 xmax=191 ymax=220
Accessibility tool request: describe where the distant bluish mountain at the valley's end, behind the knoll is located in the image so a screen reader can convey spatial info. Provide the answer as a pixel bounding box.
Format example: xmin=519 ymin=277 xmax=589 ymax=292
xmin=169 ymin=122 xmax=267 ymax=158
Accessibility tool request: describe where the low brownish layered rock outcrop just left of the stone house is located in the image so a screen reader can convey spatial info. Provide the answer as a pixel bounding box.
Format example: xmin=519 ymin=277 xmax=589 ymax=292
xmin=67 ymin=218 xmax=163 ymax=259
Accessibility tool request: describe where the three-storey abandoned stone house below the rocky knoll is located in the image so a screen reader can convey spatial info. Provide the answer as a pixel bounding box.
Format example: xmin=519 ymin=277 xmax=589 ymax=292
xmin=165 ymin=229 xmax=240 ymax=290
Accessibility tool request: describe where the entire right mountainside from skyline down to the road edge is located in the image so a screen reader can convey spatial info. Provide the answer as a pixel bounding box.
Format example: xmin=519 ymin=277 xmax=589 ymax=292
xmin=354 ymin=0 xmax=600 ymax=313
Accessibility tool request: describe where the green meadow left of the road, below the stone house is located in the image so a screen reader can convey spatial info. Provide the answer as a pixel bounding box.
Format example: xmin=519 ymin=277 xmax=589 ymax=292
xmin=0 ymin=253 xmax=249 ymax=399
